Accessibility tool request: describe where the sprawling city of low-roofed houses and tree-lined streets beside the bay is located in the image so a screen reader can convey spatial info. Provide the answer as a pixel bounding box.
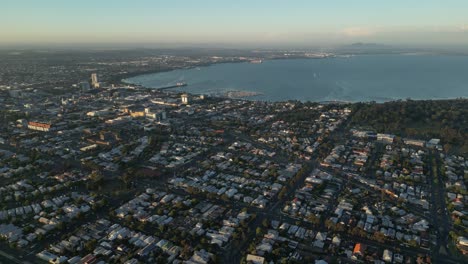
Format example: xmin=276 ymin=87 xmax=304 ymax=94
xmin=0 ymin=51 xmax=468 ymax=264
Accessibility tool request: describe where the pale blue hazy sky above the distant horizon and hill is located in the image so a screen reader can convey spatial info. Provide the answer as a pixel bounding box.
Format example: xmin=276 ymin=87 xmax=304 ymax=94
xmin=0 ymin=0 xmax=468 ymax=47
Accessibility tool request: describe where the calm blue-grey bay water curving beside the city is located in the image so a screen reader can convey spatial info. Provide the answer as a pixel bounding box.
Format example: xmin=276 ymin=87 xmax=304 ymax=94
xmin=126 ymin=55 xmax=468 ymax=102
